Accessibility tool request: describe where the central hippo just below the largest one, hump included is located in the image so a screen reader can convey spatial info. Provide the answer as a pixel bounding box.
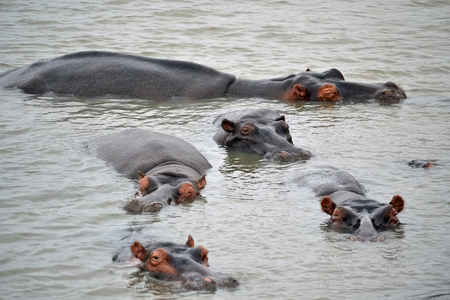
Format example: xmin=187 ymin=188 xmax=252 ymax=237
xmin=213 ymin=108 xmax=311 ymax=161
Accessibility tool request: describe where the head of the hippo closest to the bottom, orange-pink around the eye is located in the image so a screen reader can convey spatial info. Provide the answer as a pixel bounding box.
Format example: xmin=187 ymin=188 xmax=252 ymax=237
xmin=130 ymin=235 xmax=239 ymax=291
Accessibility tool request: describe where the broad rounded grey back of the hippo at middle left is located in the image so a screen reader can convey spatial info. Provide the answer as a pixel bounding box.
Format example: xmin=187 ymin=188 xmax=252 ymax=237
xmin=88 ymin=129 xmax=211 ymax=179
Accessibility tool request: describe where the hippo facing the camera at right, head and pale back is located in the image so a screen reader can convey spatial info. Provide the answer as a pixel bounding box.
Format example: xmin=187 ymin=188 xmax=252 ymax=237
xmin=298 ymin=171 xmax=405 ymax=241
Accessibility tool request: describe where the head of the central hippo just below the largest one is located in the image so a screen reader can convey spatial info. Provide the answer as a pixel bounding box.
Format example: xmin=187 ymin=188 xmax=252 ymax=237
xmin=217 ymin=115 xmax=311 ymax=161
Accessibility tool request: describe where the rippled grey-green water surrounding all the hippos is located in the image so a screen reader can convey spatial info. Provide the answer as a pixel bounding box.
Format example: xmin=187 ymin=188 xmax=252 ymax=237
xmin=0 ymin=0 xmax=450 ymax=299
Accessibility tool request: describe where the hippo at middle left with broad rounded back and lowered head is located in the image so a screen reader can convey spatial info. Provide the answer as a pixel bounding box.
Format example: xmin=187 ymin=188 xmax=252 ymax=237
xmin=87 ymin=129 xmax=211 ymax=212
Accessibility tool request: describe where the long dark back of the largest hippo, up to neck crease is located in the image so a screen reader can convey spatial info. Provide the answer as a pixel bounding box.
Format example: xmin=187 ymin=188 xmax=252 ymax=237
xmin=0 ymin=51 xmax=235 ymax=99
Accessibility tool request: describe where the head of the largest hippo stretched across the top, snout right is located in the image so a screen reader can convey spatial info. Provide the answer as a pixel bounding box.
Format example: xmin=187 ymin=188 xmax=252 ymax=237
xmin=284 ymin=69 xmax=406 ymax=104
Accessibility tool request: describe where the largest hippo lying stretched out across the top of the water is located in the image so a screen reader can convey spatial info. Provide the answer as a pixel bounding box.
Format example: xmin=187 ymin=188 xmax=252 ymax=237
xmin=0 ymin=51 xmax=406 ymax=103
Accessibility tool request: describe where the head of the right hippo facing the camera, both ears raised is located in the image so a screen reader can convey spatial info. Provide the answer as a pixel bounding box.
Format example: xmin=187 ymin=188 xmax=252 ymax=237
xmin=320 ymin=195 xmax=405 ymax=241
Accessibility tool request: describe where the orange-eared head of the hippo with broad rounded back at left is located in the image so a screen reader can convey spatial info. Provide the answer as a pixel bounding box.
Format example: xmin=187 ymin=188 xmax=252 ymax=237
xmin=124 ymin=172 xmax=206 ymax=212
